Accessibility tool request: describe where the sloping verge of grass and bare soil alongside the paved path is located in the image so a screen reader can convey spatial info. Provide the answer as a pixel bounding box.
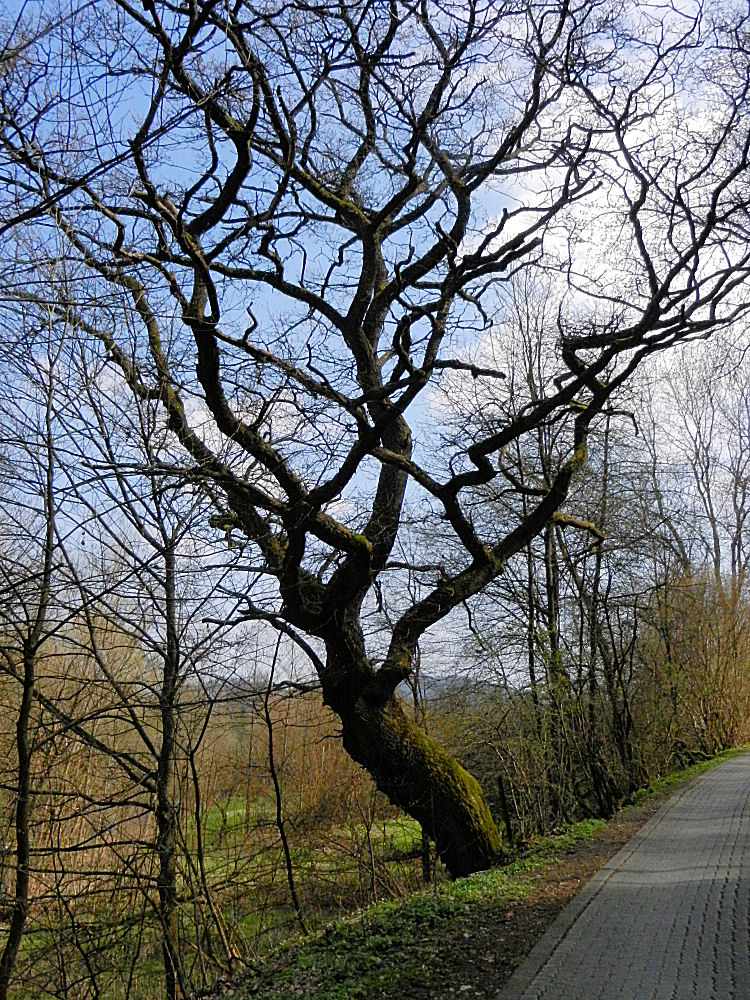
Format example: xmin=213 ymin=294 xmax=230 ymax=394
xmin=217 ymin=750 xmax=742 ymax=1000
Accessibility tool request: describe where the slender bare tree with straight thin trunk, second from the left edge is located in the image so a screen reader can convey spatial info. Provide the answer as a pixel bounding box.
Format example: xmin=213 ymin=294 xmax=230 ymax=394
xmin=53 ymin=342 xmax=254 ymax=1000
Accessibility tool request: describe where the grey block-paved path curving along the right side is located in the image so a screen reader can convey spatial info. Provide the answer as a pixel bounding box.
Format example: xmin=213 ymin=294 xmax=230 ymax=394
xmin=497 ymin=753 xmax=750 ymax=1000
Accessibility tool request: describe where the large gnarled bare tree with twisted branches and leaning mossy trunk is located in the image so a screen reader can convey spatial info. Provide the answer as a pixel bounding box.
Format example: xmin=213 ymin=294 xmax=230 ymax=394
xmin=0 ymin=0 xmax=750 ymax=875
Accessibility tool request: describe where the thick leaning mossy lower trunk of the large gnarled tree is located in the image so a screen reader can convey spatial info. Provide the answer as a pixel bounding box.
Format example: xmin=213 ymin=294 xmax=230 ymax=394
xmin=332 ymin=696 xmax=504 ymax=878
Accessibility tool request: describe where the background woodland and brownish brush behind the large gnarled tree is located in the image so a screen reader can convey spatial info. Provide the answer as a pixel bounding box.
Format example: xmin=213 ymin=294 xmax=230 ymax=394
xmin=0 ymin=322 xmax=750 ymax=1000
